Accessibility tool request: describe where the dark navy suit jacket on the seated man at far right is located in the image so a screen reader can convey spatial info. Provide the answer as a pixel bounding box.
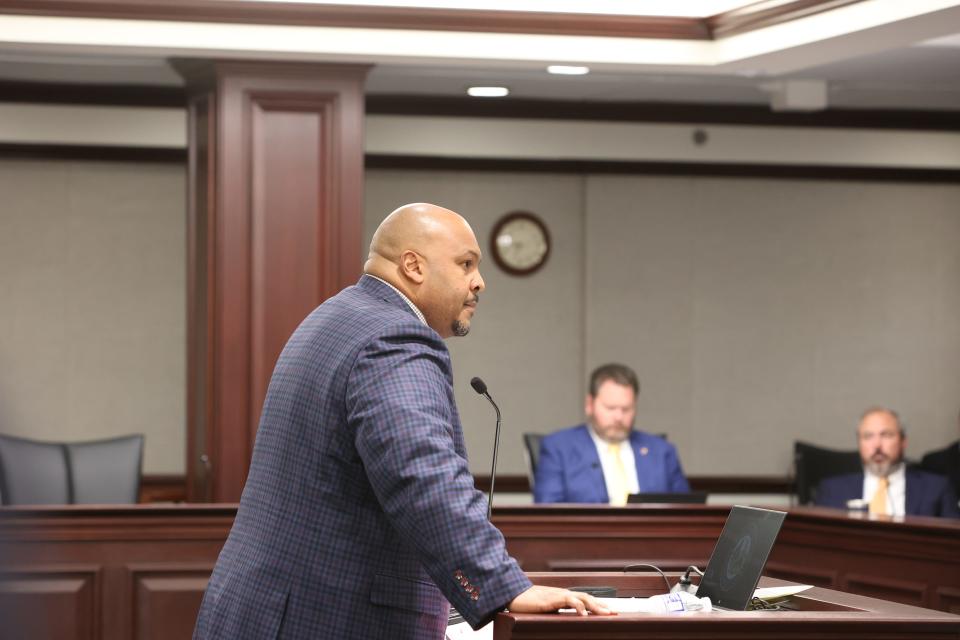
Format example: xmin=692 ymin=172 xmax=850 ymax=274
xmin=814 ymin=468 xmax=960 ymax=518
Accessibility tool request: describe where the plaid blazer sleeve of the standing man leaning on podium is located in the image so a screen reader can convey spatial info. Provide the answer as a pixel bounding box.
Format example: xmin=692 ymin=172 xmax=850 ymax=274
xmin=346 ymin=325 xmax=531 ymax=628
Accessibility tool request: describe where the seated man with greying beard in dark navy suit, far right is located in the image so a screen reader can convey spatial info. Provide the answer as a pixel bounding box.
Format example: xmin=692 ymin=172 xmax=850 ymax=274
xmin=816 ymin=408 xmax=960 ymax=518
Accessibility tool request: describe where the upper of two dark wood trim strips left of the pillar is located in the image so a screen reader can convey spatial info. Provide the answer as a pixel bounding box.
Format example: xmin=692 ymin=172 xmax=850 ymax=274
xmin=0 ymin=81 xmax=187 ymax=109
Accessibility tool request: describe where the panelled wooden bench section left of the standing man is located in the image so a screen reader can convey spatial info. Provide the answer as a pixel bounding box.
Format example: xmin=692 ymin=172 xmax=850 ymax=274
xmin=0 ymin=505 xmax=237 ymax=640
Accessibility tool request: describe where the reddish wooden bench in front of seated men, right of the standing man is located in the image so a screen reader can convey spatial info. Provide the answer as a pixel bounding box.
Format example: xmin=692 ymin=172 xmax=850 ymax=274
xmin=493 ymin=505 xmax=960 ymax=613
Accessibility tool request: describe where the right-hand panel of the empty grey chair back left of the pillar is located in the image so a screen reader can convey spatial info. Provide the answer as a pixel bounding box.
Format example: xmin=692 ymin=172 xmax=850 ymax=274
xmin=65 ymin=434 xmax=143 ymax=504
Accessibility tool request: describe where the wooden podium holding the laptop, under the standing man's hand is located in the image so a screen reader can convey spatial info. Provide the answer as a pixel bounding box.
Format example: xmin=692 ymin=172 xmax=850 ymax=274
xmin=493 ymin=572 xmax=960 ymax=640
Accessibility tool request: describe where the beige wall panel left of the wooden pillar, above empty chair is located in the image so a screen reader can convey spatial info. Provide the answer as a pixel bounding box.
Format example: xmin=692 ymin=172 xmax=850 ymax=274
xmin=0 ymin=160 xmax=186 ymax=473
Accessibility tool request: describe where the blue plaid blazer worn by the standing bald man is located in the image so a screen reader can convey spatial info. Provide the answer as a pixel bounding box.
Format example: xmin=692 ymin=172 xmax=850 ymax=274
xmin=194 ymin=276 xmax=530 ymax=640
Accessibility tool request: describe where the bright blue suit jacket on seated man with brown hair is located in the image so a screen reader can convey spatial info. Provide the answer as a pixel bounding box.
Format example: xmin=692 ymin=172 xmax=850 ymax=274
xmin=533 ymin=424 xmax=690 ymax=502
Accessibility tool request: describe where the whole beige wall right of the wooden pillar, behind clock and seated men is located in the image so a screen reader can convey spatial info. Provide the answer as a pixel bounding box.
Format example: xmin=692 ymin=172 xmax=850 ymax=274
xmin=366 ymin=171 xmax=960 ymax=475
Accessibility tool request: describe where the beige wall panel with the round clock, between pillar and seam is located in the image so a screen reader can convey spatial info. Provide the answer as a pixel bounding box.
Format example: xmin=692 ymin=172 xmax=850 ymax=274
xmin=365 ymin=171 xmax=584 ymax=474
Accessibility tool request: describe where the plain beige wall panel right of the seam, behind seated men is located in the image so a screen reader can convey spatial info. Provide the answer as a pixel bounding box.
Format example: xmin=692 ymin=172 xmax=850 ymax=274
xmin=585 ymin=177 xmax=960 ymax=474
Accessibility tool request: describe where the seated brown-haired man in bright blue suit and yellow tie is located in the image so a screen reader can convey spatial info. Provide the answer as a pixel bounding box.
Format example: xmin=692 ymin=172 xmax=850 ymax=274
xmin=533 ymin=364 xmax=690 ymax=505
